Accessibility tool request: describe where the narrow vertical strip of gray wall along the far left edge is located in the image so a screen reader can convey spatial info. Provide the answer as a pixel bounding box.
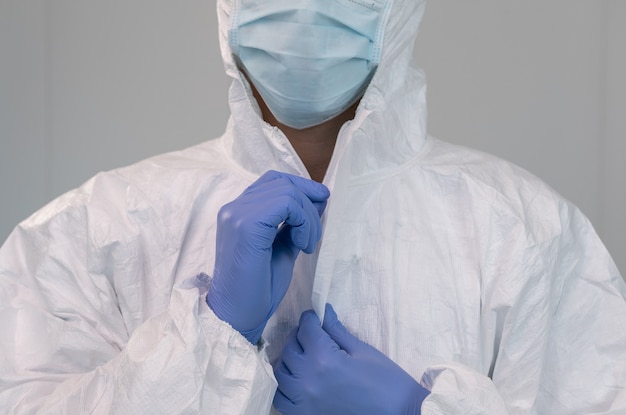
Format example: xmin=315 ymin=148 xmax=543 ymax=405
xmin=0 ymin=0 xmax=47 ymax=240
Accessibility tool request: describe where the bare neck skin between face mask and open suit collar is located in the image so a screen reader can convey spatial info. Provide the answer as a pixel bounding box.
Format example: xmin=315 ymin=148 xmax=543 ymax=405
xmin=253 ymin=88 xmax=358 ymax=183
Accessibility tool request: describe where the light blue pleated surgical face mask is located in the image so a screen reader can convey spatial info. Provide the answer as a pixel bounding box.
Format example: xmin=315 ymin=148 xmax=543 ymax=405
xmin=229 ymin=0 xmax=391 ymax=129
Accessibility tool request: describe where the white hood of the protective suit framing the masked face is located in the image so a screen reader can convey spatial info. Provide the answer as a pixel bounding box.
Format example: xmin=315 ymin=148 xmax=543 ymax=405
xmin=217 ymin=0 xmax=426 ymax=184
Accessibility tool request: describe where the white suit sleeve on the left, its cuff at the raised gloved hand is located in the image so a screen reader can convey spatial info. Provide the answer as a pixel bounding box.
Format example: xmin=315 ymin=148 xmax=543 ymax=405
xmin=0 ymin=177 xmax=276 ymax=414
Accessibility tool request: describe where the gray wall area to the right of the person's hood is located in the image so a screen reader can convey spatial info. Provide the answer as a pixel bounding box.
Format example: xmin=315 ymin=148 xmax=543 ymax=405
xmin=416 ymin=0 xmax=626 ymax=275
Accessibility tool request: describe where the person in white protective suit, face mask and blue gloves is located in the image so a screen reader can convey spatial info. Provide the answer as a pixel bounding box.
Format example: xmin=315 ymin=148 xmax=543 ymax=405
xmin=0 ymin=0 xmax=626 ymax=415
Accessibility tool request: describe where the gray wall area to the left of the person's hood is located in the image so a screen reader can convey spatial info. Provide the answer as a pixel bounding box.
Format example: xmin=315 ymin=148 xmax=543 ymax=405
xmin=0 ymin=0 xmax=229 ymax=240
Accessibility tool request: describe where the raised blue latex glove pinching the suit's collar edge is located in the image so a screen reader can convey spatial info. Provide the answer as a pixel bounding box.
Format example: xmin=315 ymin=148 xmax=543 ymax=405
xmin=207 ymin=171 xmax=330 ymax=344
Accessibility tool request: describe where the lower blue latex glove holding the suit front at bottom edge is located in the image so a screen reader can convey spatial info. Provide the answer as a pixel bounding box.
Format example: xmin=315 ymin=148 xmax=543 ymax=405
xmin=274 ymin=305 xmax=430 ymax=415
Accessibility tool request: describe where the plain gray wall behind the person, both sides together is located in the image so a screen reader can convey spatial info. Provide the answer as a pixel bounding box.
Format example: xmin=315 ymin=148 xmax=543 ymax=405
xmin=0 ymin=0 xmax=626 ymax=273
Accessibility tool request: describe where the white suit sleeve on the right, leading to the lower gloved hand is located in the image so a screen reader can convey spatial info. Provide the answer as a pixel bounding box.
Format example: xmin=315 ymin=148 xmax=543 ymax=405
xmin=422 ymin=202 xmax=626 ymax=415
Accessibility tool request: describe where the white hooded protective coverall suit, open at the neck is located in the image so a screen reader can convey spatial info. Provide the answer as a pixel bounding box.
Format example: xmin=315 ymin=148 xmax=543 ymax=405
xmin=0 ymin=0 xmax=626 ymax=415
